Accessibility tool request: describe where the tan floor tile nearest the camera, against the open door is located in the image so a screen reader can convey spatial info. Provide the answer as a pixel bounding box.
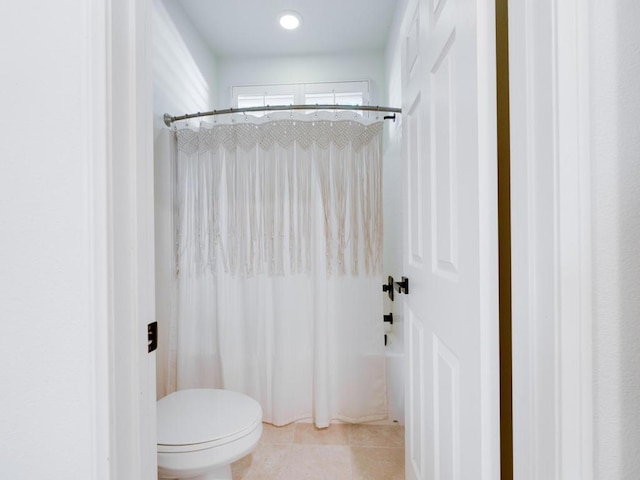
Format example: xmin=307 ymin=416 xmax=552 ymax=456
xmin=351 ymin=447 xmax=404 ymax=480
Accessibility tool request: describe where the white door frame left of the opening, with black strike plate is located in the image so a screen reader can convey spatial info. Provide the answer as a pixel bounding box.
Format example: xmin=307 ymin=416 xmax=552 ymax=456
xmin=89 ymin=0 xmax=157 ymax=480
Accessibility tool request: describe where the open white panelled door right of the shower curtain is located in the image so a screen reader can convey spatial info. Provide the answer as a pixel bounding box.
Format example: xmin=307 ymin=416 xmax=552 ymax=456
xmin=115 ymin=0 xmax=596 ymax=478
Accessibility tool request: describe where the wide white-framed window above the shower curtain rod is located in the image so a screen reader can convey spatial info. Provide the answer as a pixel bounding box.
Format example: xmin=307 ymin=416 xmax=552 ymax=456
xmin=231 ymin=80 xmax=369 ymax=116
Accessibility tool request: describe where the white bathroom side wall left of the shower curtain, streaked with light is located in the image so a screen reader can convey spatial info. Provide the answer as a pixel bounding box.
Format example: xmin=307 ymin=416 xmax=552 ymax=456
xmin=153 ymin=0 xmax=218 ymax=398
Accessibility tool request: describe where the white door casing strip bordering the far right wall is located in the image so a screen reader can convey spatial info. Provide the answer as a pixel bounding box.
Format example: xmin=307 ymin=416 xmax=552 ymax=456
xmin=554 ymin=0 xmax=593 ymax=480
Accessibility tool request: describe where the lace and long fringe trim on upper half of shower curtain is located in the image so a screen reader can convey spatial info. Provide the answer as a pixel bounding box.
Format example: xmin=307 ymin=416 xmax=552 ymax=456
xmin=174 ymin=113 xmax=383 ymax=276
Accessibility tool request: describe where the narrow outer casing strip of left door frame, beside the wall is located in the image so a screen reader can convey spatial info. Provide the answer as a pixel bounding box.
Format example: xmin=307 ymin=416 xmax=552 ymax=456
xmin=87 ymin=1 xmax=115 ymax=480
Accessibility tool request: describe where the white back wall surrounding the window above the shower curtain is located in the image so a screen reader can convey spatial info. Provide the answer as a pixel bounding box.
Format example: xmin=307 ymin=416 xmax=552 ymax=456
xmin=215 ymin=52 xmax=385 ymax=109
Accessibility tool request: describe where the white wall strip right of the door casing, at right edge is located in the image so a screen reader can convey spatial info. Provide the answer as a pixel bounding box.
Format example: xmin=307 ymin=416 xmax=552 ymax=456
xmin=590 ymin=0 xmax=640 ymax=479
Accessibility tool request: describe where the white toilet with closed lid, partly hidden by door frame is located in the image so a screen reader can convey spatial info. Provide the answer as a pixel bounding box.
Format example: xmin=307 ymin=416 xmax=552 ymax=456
xmin=157 ymin=389 xmax=262 ymax=480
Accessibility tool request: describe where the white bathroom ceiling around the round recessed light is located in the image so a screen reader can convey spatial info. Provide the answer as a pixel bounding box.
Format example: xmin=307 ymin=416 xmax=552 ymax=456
xmin=174 ymin=0 xmax=402 ymax=57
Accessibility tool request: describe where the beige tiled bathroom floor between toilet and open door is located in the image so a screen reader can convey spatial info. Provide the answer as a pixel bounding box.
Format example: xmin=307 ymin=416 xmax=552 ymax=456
xmin=231 ymin=423 xmax=404 ymax=480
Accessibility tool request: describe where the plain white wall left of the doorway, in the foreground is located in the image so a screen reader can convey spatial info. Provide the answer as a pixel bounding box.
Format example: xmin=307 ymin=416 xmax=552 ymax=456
xmin=0 ymin=0 xmax=108 ymax=480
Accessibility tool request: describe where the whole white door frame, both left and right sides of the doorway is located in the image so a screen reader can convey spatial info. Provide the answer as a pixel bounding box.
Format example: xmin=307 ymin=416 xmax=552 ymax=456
xmin=94 ymin=0 xmax=593 ymax=480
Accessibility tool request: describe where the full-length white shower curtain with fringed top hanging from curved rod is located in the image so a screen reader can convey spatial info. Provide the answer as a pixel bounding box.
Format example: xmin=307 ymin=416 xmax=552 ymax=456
xmin=167 ymin=112 xmax=386 ymax=427
